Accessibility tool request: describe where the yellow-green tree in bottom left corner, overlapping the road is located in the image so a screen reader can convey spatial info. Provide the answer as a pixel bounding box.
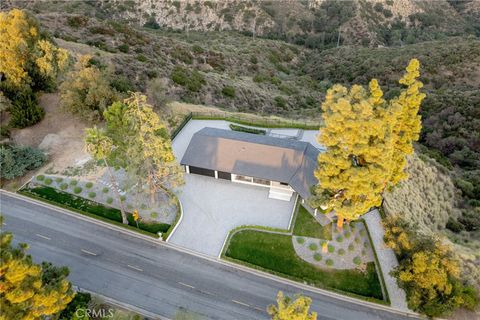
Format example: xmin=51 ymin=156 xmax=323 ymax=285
xmin=0 ymin=218 xmax=75 ymax=320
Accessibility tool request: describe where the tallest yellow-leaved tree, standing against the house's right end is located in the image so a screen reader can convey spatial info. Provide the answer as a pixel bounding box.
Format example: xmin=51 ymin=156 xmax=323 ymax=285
xmin=310 ymin=59 xmax=424 ymax=227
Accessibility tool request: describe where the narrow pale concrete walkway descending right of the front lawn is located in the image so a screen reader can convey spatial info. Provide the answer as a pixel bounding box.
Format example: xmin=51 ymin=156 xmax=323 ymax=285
xmin=363 ymin=209 xmax=411 ymax=312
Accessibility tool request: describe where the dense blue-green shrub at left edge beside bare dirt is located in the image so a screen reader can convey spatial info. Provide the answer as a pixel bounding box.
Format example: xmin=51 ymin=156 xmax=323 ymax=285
xmin=0 ymin=146 xmax=47 ymax=180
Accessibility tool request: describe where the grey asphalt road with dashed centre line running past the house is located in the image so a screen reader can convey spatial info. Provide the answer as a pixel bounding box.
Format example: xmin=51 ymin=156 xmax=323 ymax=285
xmin=0 ymin=192 xmax=412 ymax=320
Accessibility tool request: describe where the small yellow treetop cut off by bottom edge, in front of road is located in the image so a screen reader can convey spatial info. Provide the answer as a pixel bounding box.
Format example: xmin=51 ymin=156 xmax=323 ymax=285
xmin=267 ymin=291 xmax=317 ymax=320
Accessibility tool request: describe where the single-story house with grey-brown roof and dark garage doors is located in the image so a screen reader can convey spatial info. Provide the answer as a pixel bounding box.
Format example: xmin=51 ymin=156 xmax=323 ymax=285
xmin=180 ymin=127 xmax=319 ymax=205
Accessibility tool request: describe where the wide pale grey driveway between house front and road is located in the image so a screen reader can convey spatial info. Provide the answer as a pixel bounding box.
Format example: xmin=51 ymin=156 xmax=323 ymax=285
xmin=169 ymin=174 xmax=295 ymax=256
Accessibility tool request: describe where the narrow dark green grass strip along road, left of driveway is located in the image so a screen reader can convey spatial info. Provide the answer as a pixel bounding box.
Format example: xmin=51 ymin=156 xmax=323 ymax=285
xmin=19 ymin=186 xmax=170 ymax=236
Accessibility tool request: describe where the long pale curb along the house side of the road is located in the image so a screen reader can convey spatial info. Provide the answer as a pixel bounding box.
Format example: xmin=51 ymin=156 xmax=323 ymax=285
xmin=0 ymin=189 xmax=421 ymax=318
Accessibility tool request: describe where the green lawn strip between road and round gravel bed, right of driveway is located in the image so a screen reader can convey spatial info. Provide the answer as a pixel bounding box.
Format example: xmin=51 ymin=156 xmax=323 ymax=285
xmin=225 ymin=230 xmax=385 ymax=303
